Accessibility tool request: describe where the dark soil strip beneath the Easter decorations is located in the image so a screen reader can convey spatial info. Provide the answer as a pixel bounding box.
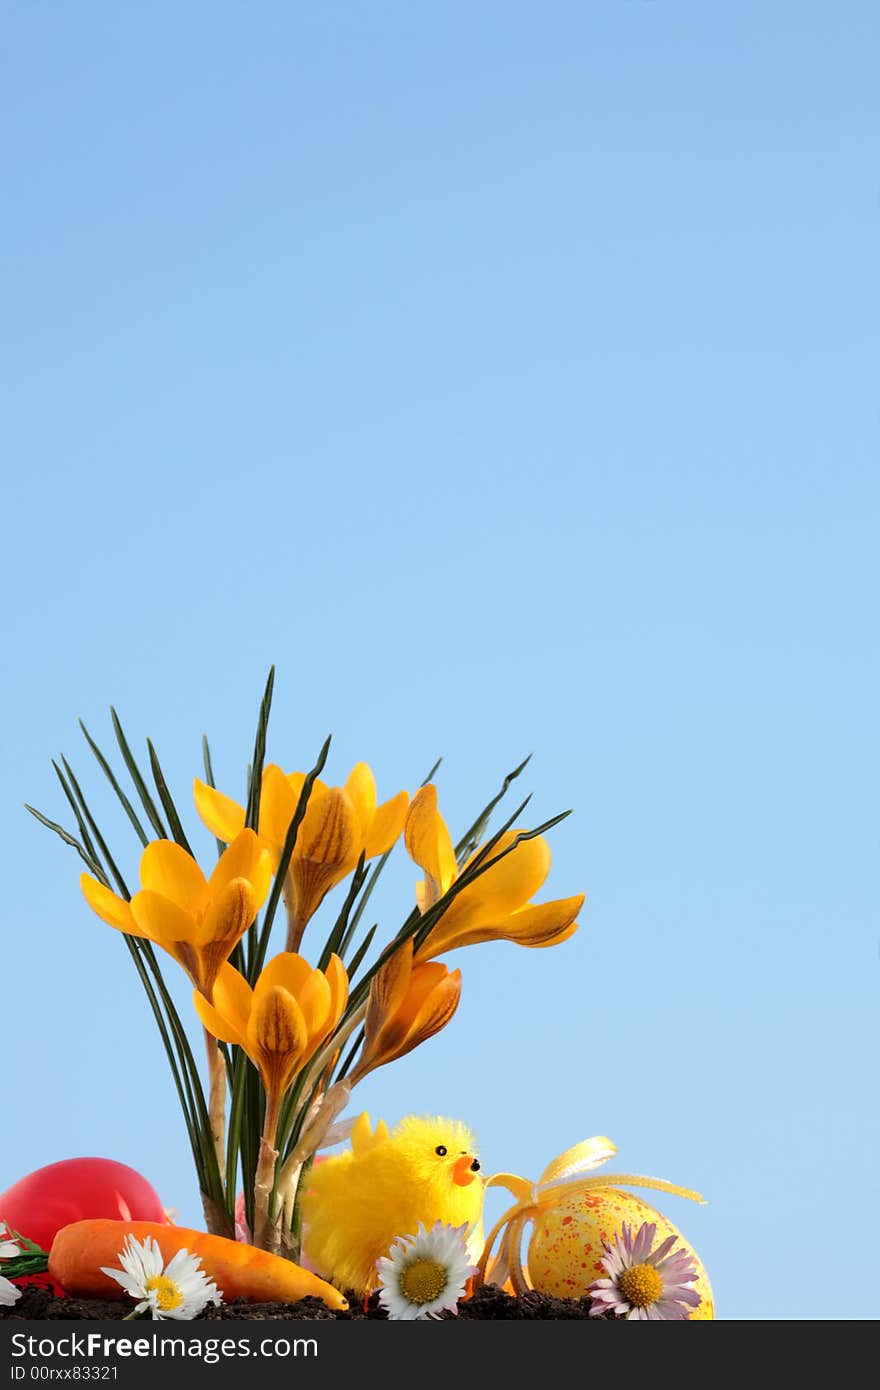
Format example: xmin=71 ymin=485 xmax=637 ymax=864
xmin=0 ymin=1284 xmax=589 ymax=1322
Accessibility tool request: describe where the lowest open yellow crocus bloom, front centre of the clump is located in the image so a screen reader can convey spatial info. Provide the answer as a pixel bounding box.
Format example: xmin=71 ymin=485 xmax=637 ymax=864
xmin=193 ymin=951 xmax=349 ymax=1106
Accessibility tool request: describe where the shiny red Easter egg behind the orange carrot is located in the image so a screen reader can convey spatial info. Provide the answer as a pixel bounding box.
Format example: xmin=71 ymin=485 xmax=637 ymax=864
xmin=0 ymin=1158 xmax=165 ymax=1251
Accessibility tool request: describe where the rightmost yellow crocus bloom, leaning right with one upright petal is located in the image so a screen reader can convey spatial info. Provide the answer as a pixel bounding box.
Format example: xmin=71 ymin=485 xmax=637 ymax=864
xmin=405 ymin=784 xmax=584 ymax=960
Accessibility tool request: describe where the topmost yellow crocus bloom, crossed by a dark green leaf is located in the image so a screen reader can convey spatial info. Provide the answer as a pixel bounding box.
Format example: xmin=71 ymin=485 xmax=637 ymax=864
xmin=193 ymin=763 xmax=409 ymax=951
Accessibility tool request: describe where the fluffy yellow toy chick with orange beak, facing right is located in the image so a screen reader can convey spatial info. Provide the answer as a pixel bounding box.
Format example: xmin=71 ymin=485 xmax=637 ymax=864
xmin=303 ymin=1113 xmax=484 ymax=1294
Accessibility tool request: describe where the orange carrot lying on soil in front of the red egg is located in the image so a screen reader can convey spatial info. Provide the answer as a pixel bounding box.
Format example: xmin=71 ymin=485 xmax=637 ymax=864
xmin=49 ymin=1219 xmax=348 ymax=1309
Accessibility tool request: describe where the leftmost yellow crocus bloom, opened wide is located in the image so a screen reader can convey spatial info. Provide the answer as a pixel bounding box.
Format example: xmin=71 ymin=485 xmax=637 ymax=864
xmin=79 ymin=830 xmax=272 ymax=999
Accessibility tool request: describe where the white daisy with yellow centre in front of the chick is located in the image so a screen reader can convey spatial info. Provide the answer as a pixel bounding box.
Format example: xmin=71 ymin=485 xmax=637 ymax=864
xmin=377 ymin=1220 xmax=477 ymax=1319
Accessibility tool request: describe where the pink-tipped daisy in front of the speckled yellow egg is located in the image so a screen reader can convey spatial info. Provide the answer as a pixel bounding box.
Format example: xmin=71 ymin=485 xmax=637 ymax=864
xmin=587 ymin=1222 xmax=701 ymax=1322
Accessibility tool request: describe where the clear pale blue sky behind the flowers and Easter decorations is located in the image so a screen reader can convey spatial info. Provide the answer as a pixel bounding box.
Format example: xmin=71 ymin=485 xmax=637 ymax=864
xmin=0 ymin=0 xmax=880 ymax=1318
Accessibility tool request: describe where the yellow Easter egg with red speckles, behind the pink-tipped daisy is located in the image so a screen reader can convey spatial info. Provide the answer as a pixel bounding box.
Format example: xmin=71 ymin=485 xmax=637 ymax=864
xmin=528 ymin=1187 xmax=715 ymax=1321
